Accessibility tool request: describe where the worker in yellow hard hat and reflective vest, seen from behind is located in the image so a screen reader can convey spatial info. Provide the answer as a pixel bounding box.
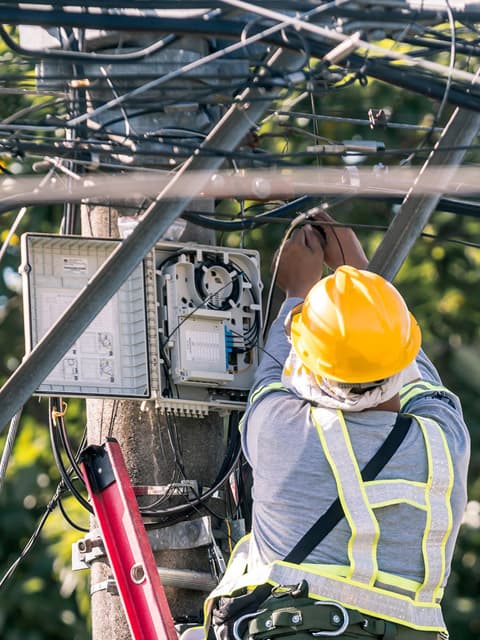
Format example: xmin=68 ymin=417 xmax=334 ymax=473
xmin=207 ymin=210 xmax=469 ymax=640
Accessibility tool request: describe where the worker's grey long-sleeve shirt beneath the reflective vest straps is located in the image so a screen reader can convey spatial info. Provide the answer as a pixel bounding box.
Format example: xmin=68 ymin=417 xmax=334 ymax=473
xmin=242 ymin=298 xmax=470 ymax=581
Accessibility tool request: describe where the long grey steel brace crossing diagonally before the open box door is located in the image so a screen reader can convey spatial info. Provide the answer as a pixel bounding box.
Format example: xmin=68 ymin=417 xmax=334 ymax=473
xmin=0 ymin=49 xmax=291 ymax=433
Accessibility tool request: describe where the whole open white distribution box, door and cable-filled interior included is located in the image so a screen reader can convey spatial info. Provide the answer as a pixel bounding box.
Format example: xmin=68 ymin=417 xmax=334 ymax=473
xmin=21 ymin=234 xmax=262 ymax=416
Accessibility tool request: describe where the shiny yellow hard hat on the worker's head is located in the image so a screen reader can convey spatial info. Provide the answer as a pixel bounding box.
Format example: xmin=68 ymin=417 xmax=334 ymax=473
xmin=290 ymin=265 xmax=421 ymax=383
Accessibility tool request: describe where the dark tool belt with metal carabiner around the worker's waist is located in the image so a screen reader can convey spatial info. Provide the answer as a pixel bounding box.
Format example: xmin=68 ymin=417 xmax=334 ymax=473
xmin=213 ymin=580 xmax=444 ymax=640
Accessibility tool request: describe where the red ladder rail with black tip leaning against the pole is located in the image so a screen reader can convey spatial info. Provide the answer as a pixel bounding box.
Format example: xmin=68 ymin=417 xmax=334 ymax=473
xmin=80 ymin=438 xmax=178 ymax=640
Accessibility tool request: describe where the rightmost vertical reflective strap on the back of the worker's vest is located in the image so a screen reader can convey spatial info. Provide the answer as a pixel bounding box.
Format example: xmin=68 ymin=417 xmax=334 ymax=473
xmin=414 ymin=416 xmax=454 ymax=602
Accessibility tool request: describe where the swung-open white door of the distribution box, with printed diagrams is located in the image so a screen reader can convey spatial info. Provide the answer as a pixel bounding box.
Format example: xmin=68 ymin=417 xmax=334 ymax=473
xmin=21 ymin=234 xmax=151 ymax=398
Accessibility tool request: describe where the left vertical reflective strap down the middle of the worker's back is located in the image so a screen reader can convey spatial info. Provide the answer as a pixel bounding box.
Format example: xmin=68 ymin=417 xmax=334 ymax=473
xmin=311 ymin=407 xmax=380 ymax=585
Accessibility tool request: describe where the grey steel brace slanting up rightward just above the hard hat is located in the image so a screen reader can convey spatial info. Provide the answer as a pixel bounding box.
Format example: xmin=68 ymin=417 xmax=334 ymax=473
xmin=368 ymin=107 xmax=480 ymax=280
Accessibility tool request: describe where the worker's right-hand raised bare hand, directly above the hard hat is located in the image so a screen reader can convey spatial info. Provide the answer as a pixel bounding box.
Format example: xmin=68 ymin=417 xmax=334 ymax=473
xmin=312 ymin=209 xmax=368 ymax=270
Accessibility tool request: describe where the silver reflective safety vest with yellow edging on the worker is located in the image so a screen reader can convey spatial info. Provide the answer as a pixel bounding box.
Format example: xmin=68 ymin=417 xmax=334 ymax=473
xmin=190 ymin=382 xmax=454 ymax=632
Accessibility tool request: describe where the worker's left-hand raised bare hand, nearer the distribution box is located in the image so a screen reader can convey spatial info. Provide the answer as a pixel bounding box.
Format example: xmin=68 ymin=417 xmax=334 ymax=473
xmin=273 ymin=224 xmax=324 ymax=298
